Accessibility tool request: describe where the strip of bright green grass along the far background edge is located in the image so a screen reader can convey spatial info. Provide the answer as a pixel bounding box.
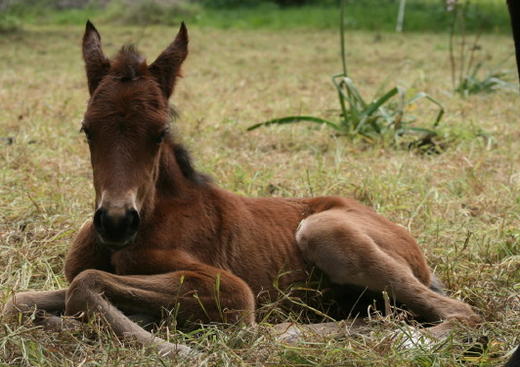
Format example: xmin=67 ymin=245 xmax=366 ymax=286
xmin=0 ymin=0 xmax=510 ymax=33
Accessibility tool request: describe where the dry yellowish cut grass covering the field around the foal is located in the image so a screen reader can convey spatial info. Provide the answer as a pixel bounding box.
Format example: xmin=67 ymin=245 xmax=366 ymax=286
xmin=0 ymin=24 xmax=520 ymax=367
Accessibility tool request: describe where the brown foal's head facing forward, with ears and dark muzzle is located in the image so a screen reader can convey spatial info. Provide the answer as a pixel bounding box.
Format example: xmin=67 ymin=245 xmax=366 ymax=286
xmin=82 ymin=21 xmax=188 ymax=249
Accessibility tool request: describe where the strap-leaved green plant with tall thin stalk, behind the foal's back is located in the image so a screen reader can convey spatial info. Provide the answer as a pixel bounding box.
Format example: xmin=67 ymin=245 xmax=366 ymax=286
xmin=247 ymin=1 xmax=444 ymax=144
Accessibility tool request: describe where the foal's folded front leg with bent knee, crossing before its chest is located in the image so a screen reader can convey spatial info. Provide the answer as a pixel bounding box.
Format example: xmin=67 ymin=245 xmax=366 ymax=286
xmin=66 ymin=264 xmax=254 ymax=356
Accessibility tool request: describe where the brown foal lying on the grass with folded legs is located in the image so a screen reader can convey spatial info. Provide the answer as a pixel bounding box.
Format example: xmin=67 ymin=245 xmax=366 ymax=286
xmin=5 ymin=22 xmax=478 ymax=355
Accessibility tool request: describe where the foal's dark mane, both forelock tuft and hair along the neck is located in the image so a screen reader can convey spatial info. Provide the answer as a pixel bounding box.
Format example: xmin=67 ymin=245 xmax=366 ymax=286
xmin=109 ymin=44 xmax=211 ymax=185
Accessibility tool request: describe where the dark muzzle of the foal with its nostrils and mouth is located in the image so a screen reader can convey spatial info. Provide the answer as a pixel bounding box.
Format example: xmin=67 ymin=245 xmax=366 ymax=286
xmin=94 ymin=207 xmax=140 ymax=249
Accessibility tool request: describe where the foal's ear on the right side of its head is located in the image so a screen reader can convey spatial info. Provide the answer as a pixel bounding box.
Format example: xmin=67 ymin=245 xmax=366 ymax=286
xmin=148 ymin=22 xmax=188 ymax=98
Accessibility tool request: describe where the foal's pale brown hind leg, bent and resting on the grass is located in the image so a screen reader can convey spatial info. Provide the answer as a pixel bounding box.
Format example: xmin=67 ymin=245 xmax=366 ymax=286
xmin=296 ymin=209 xmax=478 ymax=334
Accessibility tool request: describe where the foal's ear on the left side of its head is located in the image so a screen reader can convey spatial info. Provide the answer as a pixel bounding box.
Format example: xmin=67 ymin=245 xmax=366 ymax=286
xmin=83 ymin=20 xmax=110 ymax=95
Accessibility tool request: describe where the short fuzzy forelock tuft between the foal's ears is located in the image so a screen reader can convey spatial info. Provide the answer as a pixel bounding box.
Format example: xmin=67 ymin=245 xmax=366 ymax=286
xmin=110 ymin=45 xmax=148 ymax=82
